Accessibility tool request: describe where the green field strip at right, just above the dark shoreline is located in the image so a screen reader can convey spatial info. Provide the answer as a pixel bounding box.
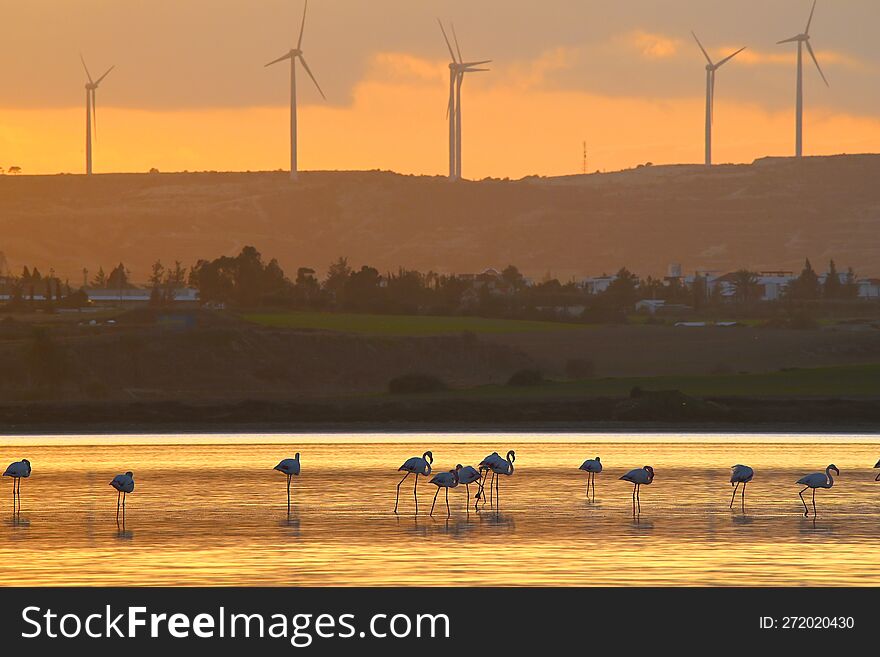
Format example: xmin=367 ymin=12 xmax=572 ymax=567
xmin=432 ymin=364 xmax=880 ymax=398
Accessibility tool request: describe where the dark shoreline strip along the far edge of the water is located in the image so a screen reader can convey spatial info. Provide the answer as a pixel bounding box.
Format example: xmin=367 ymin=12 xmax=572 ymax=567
xmin=0 ymin=397 xmax=880 ymax=436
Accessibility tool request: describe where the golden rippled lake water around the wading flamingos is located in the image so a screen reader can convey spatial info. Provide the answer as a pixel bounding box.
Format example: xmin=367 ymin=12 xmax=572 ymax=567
xmin=0 ymin=437 xmax=880 ymax=586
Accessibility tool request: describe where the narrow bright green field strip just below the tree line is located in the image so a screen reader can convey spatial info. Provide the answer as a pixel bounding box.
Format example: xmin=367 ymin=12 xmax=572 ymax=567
xmin=244 ymin=312 xmax=584 ymax=336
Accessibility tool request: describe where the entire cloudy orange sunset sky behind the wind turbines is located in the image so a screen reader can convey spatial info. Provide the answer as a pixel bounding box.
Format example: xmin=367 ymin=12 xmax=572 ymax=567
xmin=0 ymin=0 xmax=880 ymax=178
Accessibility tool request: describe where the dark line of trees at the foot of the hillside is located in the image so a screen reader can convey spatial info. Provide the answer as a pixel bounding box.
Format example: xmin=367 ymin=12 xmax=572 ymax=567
xmin=0 ymin=246 xmax=858 ymax=321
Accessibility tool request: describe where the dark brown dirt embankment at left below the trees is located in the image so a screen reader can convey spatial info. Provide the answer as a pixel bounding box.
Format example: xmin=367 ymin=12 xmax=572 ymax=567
xmin=0 ymin=312 xmax=531 ymax=402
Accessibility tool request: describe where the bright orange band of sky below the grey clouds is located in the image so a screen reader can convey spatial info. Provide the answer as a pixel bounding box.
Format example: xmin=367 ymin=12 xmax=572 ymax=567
xmin=0 ymin=48 xmax=880 ymax=178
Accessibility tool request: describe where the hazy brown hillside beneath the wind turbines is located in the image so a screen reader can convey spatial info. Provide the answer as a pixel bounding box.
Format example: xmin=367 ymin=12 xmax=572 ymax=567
xmin=0 ymin=155 xmax=880 ymax=283
